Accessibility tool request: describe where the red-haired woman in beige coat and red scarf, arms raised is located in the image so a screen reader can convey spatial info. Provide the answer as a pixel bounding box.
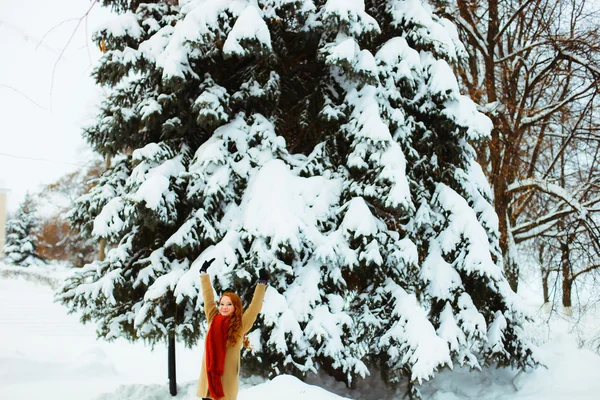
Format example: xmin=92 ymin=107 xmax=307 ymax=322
xmin=197 ymin=258 xmax=269 ymax=400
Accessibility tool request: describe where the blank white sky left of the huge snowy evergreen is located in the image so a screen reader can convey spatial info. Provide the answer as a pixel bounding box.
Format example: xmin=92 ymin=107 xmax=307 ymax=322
xmin=0 ymin=0 xmax=109 ymax=212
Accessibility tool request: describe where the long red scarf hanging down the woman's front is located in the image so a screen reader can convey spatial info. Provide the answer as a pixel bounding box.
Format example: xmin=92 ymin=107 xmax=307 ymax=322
xmin=205 ymin=314 xmax=229 ymax=400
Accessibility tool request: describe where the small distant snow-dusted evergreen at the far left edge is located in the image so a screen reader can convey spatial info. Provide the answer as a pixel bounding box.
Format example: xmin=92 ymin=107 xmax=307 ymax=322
xmin=4 ymin=193 xmax=43 ymax=267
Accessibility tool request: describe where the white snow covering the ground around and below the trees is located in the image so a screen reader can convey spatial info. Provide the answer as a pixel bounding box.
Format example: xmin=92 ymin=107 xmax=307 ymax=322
xmin=0 ymin=264 xmax=600 ymax=400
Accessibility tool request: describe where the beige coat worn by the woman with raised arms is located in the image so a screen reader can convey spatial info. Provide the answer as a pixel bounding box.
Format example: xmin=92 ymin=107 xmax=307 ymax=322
xmin=197 ymin=274 xmax=267 ymax=400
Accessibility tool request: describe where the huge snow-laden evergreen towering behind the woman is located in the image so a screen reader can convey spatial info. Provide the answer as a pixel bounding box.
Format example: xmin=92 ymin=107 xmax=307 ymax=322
xmin=59 ymin=0 xmax=535 ymax=397
